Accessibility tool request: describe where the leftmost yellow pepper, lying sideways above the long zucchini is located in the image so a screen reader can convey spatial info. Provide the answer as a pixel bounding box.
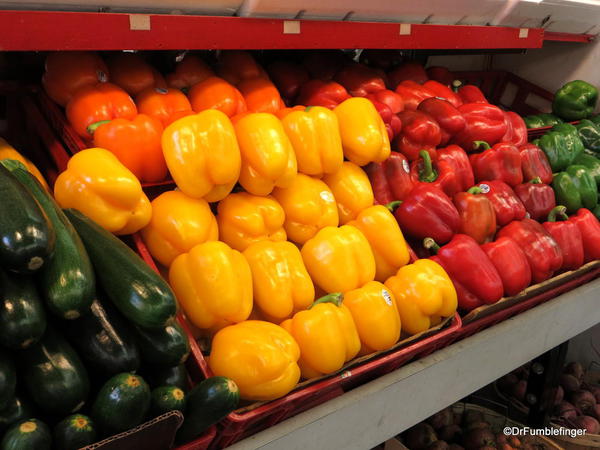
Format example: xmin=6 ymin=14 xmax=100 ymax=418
xmin=54 ymin=148 xmax=152 ymax=234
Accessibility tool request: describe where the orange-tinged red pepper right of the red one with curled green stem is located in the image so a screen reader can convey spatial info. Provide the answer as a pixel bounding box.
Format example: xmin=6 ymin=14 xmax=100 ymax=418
xmin=453 ymin=186 xmax=496 ymax=244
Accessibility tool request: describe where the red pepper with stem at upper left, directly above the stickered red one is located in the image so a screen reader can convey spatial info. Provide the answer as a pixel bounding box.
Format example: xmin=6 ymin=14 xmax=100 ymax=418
xmin=469 ymin=141 xmax=523 ymax=187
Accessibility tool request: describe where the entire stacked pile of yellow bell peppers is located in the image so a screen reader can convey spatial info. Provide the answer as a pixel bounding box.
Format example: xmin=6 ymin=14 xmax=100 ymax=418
xmin=55 ymin=98 xmax=457 ymax=400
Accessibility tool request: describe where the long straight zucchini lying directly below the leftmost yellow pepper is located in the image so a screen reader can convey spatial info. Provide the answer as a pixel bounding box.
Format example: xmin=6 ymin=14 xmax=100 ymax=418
xmin=65 ymin=209 xmax=177 ymax=328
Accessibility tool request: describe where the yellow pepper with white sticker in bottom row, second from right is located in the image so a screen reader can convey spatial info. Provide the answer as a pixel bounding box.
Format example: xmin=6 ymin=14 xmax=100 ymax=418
xmin=344 ymin=281 xmax=401 ymax=354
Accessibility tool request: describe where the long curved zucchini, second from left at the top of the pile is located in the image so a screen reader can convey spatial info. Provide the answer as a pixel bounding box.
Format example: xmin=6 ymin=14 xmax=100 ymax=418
xmin=1 ymin=160 xmax=96 ymax=319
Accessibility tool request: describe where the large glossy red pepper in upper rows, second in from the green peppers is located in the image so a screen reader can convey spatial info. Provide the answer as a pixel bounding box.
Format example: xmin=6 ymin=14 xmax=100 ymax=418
xmin=452 ymin=103 xmax=506 ymax=152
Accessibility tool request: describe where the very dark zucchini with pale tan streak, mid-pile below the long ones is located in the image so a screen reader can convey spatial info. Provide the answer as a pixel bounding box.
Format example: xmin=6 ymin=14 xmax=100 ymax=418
xmin=67 ymin=300 xmax=140 ymax=381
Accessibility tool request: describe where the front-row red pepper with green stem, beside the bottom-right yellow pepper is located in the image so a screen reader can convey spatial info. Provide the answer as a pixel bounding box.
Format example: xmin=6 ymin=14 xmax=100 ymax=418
xmin=423 ymin=234 xmax=504 ymax=311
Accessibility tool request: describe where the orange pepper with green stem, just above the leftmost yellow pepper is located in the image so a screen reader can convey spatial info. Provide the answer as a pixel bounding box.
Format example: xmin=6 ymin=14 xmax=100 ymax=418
xmin=88 ymin=114 xmax=167 ymax=183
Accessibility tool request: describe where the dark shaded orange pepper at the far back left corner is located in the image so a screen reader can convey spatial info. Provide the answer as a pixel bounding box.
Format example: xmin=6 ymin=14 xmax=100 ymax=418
xmin=42 ymin=51 xmax=108 ymax=106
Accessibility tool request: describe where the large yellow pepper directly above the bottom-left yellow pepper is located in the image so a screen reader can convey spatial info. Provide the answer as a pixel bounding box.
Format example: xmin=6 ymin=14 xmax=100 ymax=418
xmin=169 ymin=241 xmax=253 ymax=329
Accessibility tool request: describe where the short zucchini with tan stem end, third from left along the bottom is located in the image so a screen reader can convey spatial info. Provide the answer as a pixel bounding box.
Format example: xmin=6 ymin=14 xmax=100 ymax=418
xmin=92 ymin=373 xmax=150 ymax=434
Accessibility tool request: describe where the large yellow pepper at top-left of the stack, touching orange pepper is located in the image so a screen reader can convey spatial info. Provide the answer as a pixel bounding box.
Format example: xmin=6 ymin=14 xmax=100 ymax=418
xmin=162 ymin=109 xmax=241 ymax=202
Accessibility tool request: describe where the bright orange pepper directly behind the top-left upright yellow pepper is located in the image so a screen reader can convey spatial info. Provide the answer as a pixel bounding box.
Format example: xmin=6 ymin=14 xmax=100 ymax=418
xmin=188 ymin=77 xmax=246 ymax=117
